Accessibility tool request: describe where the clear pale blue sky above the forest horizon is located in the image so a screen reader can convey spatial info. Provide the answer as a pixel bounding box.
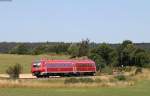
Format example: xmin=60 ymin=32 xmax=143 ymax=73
xmin=0 ymin=0 xmax=150 ymax=43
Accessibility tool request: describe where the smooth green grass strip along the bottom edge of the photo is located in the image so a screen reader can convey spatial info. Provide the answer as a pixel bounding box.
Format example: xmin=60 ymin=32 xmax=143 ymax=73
xmin=0 ymin=80 xmax=150 ymax=96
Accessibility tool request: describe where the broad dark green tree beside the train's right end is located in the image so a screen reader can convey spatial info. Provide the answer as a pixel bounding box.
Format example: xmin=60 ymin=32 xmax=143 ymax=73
xmin=89 ymin=43 xmax=117 ymax=71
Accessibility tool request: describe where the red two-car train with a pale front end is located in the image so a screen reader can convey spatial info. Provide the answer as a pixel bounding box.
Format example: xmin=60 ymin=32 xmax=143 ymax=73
xmin=31 ymin=59 xmax=96 ymax=78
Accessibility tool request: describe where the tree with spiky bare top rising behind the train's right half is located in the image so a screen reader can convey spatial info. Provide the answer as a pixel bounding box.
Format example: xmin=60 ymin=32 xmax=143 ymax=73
xmin=78 ymin=39 xmax=90 ymax=57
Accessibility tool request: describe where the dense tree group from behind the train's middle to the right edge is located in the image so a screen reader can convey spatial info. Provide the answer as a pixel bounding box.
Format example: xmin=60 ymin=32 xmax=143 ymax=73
xmin=68 ymin=40 xmax=150 ymax=71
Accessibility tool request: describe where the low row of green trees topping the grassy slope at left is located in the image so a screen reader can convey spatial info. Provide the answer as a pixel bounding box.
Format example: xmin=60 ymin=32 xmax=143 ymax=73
xmin=8 ymin=43 xmax=70 ymax=55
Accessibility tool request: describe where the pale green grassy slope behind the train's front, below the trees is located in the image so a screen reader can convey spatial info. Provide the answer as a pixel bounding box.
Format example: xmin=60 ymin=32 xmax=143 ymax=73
xmin=0 ymin=54 xmax=68 ymax=74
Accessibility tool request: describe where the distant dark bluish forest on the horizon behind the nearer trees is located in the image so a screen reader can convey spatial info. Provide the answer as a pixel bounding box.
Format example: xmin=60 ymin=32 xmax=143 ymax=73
xmin=0 ymin=41 xmax=150 ymax=54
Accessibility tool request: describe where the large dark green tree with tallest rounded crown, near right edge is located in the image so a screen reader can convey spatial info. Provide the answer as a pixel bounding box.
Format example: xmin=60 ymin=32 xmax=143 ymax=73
xmin=117 ymin=40 xmax=149 ymax=67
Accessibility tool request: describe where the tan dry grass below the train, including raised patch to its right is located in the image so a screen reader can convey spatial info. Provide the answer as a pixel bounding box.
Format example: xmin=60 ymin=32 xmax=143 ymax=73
xmin=0 ymin=75 xmax=134 ymax=88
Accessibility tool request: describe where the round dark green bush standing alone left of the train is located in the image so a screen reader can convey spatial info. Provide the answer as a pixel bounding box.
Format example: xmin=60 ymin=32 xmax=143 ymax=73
xmin=6 ymin=64 xmax=22 ymax=79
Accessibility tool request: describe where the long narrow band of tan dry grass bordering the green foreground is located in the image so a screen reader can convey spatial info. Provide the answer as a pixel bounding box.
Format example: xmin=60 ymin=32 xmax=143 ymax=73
xmin=0 ymin=80 xmax=134 ymax=88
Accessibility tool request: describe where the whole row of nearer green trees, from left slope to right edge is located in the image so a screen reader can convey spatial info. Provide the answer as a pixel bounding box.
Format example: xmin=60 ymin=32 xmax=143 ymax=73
xmin=0 ymin=39 xmax=150 ymax=71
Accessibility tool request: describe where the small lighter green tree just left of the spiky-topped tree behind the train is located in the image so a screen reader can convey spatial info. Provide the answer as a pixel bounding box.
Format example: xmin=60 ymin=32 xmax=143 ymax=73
xmin=68 ymin=43 xmax=79 ymax=58
